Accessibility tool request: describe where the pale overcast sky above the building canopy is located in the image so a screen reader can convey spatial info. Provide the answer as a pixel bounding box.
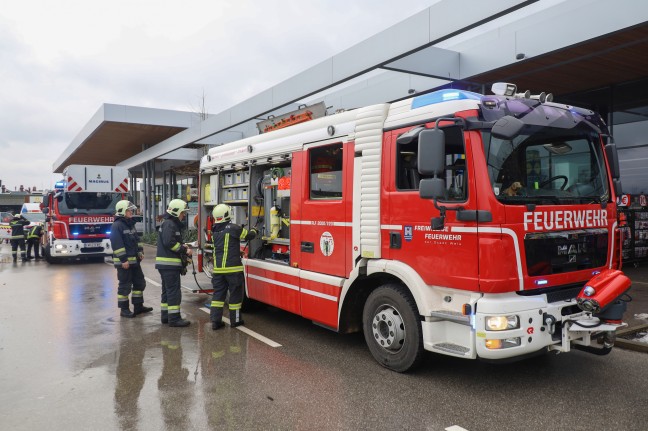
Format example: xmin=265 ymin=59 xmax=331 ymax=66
xmin=0 ymin=0 xmax=436 ymax=190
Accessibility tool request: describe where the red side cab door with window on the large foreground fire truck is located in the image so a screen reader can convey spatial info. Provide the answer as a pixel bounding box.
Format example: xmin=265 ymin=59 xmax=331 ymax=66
xmin=381 ymin=124 xmax=479 ymax=291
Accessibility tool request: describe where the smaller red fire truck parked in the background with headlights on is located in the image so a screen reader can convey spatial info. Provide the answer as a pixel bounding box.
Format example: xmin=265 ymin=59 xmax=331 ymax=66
xmin=42 ymin=165 xmax=129 ymax=263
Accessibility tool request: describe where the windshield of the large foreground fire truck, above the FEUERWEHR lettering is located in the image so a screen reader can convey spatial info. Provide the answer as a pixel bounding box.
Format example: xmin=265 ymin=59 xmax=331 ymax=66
xmin=484 ymin=126 xmax=610 ymax=205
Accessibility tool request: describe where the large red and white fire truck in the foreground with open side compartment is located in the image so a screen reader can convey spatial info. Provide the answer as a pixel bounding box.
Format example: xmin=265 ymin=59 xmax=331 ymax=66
xmin=199 ymin=83 xmax=630 ymax=371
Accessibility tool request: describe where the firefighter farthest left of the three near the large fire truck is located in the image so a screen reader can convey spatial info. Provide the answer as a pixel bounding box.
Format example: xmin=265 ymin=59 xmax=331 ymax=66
xmin=110 ymin=200 xmax=153 ymax=318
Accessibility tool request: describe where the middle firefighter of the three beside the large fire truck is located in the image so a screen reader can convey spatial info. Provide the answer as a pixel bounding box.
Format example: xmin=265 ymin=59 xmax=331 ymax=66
xmin=155 ymin=199 xmax=191 ymax=327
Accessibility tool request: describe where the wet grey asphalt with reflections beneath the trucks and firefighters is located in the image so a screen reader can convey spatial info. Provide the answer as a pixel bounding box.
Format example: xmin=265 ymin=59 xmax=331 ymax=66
xmin=0 ymin=245 xmax=648 ymax=431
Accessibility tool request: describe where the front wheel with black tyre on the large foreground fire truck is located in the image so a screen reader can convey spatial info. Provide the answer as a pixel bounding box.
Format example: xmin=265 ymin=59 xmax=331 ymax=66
xmin=362 ymin=284 xmax=424 ymax=373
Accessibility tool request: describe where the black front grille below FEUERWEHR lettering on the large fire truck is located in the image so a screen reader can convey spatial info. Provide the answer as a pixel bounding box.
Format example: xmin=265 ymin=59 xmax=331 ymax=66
xmin=524 ymin=229 xmax=608 ymax=277
